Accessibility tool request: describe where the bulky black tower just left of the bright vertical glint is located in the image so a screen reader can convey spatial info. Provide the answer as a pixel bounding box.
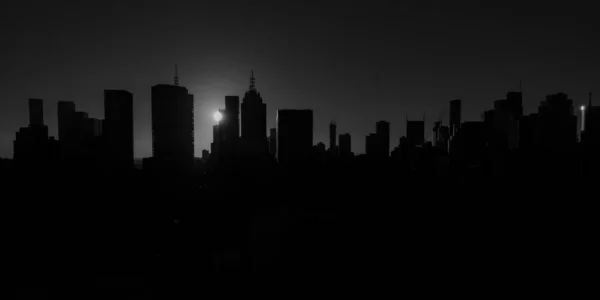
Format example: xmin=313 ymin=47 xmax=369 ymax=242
xmin=537 ymin=93 xmax=577 ymax=150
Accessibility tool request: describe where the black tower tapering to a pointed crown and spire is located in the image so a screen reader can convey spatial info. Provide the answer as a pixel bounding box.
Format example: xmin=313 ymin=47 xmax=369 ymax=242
xmin=242 ymin=71 xmax=268 ymax=155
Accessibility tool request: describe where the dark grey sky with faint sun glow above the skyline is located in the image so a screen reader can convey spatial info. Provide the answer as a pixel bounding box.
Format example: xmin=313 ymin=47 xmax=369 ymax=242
xmin=0 ymin=0 xmax=600 ymax=157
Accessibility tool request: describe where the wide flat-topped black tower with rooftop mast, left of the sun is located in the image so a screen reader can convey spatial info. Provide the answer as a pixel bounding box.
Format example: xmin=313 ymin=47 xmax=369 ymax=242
xmin=152 ymin=84 xmax=194 ymax=171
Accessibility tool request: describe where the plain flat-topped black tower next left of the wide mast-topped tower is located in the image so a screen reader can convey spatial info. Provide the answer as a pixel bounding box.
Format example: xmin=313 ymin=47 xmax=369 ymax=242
xmin=103 ymin=90 xmax=133 ymax=168
